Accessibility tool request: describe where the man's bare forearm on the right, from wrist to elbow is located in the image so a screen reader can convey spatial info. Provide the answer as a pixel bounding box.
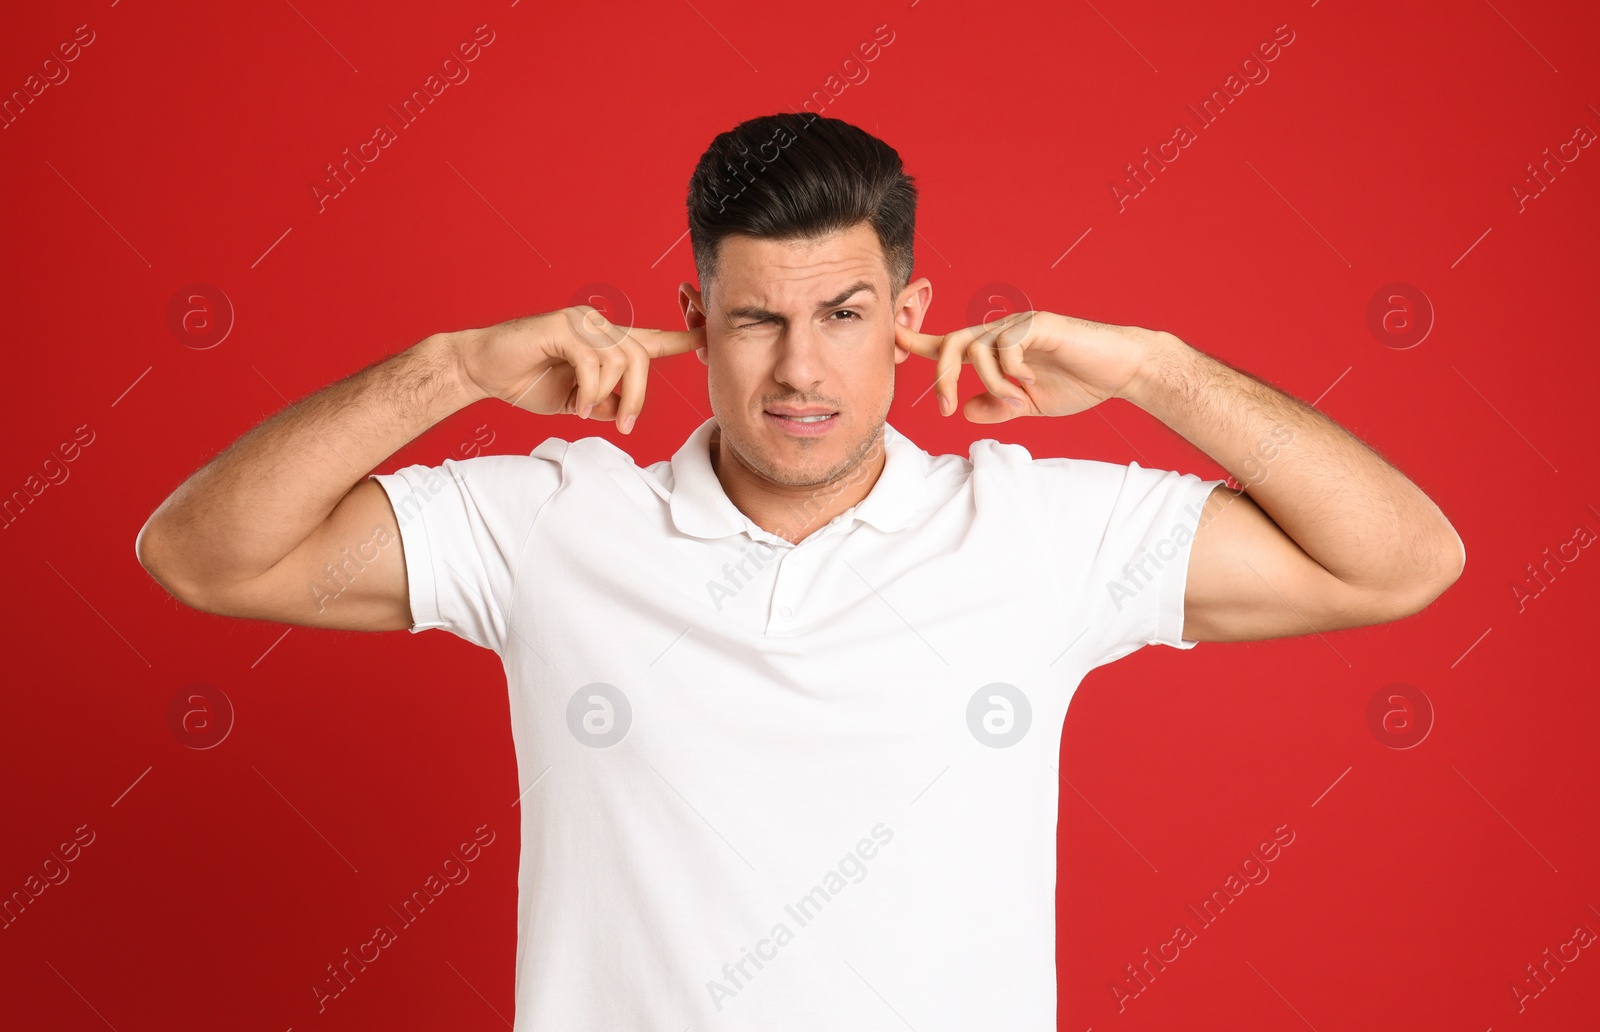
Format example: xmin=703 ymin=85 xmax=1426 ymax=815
xmin=1122 ymin=334 xmax=1464 ymax=592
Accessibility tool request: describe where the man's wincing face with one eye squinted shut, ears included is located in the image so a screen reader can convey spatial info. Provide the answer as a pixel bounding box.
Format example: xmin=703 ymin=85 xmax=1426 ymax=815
xmin=680 ymin=222 xmax=933 ymax=488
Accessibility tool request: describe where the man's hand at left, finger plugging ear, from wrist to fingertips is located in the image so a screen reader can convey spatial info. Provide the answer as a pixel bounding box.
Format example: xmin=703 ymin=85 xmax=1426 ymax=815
xmin=448 ymin=304 xmax=706 ymax=434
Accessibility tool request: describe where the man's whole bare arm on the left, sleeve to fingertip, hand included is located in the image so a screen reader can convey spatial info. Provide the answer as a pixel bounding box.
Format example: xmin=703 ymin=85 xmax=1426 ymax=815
xmin=134 ymin=306 xmax=704 ymax=630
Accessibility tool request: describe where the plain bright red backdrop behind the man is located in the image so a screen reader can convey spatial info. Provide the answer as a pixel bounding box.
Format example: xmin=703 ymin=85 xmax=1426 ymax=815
xmin=0 ymin=0 xmax=1600 ymax=1032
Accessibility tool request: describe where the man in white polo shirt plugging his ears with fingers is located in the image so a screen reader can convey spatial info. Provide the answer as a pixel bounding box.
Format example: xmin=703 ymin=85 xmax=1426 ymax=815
xmin=138 ymin=115 xmax=1464 ymax=1032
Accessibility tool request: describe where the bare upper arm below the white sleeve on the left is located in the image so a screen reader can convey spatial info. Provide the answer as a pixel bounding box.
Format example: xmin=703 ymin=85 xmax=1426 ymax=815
xmin=198 ymin=478 xmax=413 ymax=630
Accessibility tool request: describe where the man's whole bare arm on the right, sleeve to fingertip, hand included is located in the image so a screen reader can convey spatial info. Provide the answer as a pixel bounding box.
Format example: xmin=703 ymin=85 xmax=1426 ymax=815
xmin=896 ymin=312 xmax=1466 ymax=642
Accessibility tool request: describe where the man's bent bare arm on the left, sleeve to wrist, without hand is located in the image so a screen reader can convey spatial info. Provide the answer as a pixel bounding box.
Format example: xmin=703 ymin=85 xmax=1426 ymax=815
xmin=134 ymin=334 xmax=485 ymax=630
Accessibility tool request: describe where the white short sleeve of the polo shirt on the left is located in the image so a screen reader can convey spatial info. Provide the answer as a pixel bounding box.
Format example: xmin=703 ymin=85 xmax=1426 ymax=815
xmin=370 ymin=438 xmax=566 ymax=654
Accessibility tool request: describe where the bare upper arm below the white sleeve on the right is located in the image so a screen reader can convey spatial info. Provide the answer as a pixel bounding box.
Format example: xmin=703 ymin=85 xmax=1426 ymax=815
xmin=1184 ymin=488 xmax=1398 ymax=642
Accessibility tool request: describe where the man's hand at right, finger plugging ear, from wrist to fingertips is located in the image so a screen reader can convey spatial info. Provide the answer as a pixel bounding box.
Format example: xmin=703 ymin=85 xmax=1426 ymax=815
xmin=894 ymin=312 xmax=1166 ymax=422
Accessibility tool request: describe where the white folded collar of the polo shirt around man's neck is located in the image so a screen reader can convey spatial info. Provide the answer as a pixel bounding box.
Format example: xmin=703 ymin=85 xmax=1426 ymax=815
xmin=670 ymin=416 xmax=928 ymax=538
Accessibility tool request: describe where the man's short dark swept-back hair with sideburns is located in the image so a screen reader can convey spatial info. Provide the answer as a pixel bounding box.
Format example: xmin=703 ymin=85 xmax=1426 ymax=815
xmin=688 ymin=112 xmax=917 ymax=305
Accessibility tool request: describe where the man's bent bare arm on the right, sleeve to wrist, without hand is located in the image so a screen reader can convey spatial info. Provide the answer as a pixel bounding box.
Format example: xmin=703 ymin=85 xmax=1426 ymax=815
xmin=1122 ymin=333 xmax=1466 ymax=642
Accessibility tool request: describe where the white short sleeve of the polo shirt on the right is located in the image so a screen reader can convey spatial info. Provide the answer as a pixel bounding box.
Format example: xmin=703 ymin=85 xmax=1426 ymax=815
xmin=1035 ymin=459 xmax=1226 ymax=669
